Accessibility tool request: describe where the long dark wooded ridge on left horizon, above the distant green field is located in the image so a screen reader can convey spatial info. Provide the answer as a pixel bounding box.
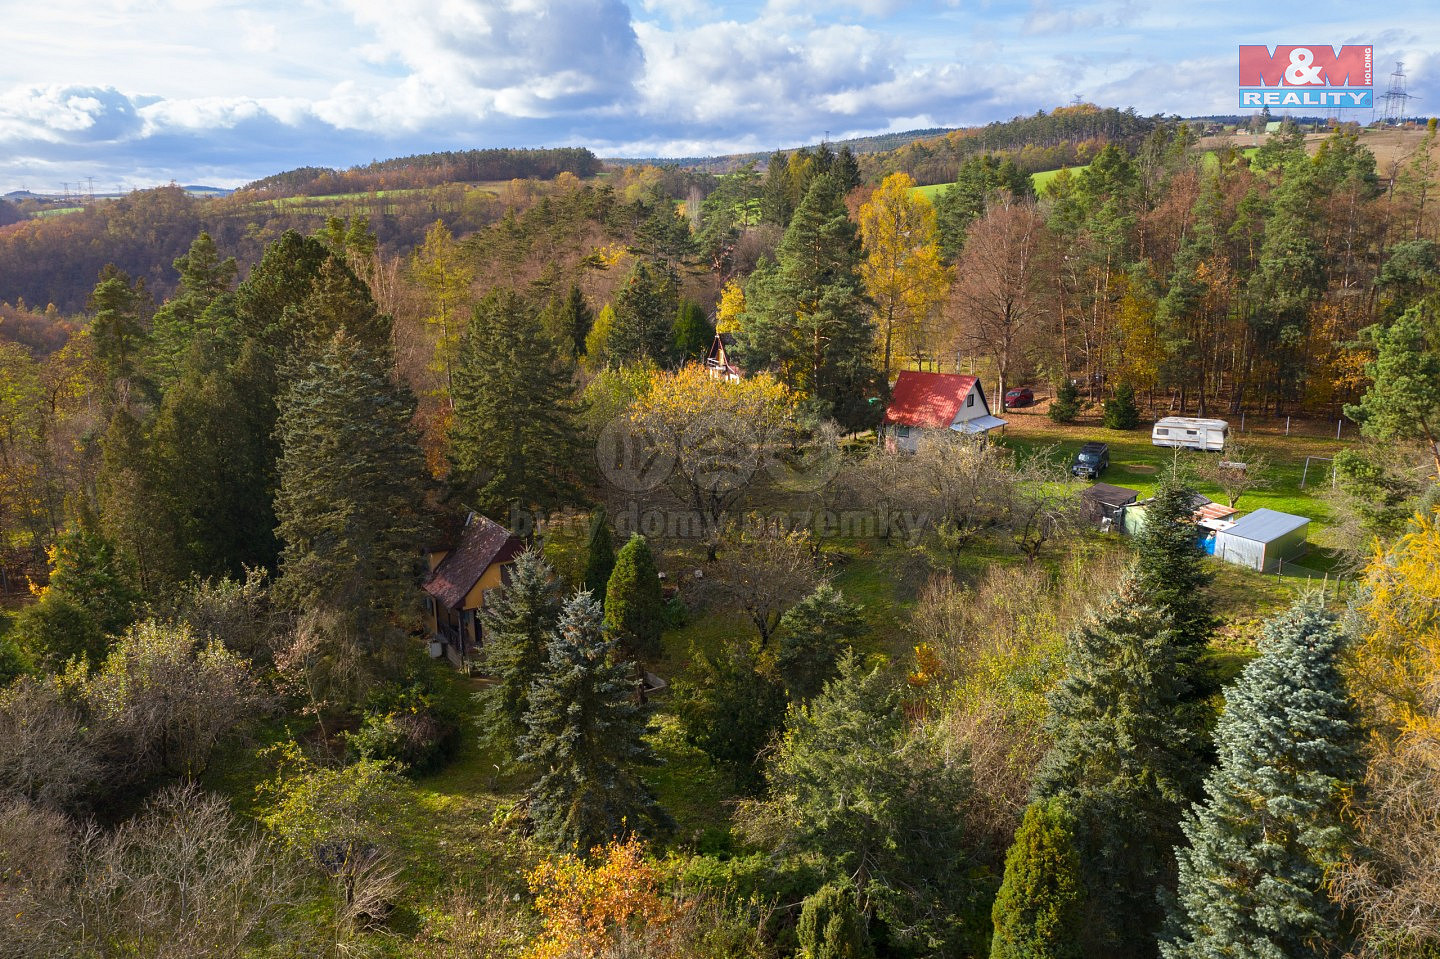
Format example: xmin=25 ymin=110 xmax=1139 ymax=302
xmin=245 ymin=147 xmax=600 ymax=196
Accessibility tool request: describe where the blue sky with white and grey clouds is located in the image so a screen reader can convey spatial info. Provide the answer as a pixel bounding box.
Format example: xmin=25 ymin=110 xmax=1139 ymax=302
xmin=0 ymin=0 xmax=1440 ymax=194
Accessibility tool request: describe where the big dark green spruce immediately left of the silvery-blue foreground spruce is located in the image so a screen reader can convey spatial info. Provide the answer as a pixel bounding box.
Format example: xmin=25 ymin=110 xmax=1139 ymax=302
xmin=1032 ymin=577 xmax=1202 ymax=956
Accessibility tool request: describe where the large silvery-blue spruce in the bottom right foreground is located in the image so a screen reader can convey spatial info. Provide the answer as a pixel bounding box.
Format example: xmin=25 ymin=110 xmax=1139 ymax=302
xmin=1161 ymin=599 xmax=1361 ymax=959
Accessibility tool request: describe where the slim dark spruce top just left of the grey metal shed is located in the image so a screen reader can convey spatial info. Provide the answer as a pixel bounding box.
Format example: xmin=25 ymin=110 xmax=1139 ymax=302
xmin=1133 ymin=471 xmax=1215 ymax=682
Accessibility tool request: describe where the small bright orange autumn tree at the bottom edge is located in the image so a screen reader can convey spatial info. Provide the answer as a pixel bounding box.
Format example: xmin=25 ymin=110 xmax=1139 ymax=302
xmin=526 ymin=837 xmax=693 ymax=959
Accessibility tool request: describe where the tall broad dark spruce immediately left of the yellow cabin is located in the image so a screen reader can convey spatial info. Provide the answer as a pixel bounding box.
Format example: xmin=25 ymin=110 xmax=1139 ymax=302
xmin=275 ymin=331 xmax=425 ymax=628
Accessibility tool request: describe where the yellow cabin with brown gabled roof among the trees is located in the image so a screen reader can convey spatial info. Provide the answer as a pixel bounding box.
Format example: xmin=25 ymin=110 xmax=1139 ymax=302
xmin=425 ymin=513 xmax=526 ymax=668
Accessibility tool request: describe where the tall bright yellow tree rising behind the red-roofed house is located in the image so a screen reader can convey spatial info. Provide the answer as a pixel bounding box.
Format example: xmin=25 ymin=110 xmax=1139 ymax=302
xmin=860 ymin=173 xmax=950 ymax=380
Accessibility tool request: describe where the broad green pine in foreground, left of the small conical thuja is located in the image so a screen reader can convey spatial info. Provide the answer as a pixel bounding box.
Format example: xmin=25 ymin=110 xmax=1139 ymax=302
xmin=740 ymin=654 xmax=989 ymax=956
